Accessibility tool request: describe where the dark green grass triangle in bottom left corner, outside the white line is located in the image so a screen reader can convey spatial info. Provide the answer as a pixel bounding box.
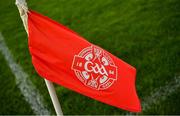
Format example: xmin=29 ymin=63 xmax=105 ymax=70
xmin=0 ymin=53 xmax=33 ymax=115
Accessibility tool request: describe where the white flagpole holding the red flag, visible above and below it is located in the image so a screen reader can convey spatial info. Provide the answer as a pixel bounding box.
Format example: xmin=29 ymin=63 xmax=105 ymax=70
xmin=16 ymin=0 xmax=63 ymax=115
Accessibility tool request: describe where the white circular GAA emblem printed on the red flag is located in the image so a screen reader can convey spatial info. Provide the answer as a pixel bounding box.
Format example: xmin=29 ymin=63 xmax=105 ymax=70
xmin=72 ymin=46 xmax=117 ymax=90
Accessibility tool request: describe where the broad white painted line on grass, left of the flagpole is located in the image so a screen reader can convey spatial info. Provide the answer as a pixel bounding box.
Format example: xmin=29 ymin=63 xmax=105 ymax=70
xmin=0 ymin=32 xmax=51 ymax=115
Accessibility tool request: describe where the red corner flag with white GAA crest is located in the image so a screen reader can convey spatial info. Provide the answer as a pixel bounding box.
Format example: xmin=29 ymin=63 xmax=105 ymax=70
xmin=28 ymin=11 xmax=141 ymax=112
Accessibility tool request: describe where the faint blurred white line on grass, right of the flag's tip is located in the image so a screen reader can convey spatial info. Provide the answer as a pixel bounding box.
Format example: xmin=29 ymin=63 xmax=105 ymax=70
xmin=142 ymin=76 xmax=180 ymax=112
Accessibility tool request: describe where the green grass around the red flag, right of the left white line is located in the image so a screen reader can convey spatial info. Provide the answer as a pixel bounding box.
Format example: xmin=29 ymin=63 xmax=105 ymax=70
xmin=0 ymin=0 xmax=180 ymax=114
